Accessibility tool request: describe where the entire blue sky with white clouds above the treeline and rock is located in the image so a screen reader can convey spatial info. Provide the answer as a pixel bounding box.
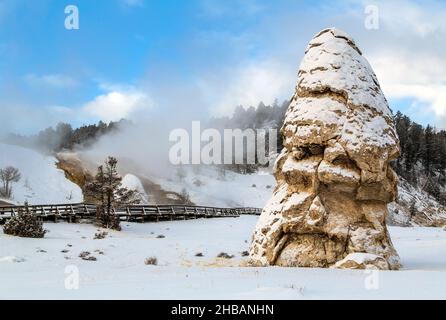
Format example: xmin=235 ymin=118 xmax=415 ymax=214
xmin=0 ymin=0 xmax=446 ymax=133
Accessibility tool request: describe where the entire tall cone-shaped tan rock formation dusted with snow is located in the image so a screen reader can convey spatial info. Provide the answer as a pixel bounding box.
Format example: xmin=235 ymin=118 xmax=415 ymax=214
xmin=250 ymin=28 xmax=400 ymax=270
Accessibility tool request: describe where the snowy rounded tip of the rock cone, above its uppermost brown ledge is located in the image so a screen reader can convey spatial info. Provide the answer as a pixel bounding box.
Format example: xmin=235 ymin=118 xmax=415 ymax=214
xmin=299 ymin=29 xmax=391 ymax=116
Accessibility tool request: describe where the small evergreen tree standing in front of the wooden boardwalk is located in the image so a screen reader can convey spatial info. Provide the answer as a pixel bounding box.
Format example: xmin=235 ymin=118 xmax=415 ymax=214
xmin=85 ymin=157 xmax=140 ymax=230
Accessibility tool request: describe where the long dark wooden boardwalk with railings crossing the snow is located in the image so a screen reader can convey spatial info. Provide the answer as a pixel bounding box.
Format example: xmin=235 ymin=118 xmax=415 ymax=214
xmin=0 ymin=203 xmax=262 ymax=224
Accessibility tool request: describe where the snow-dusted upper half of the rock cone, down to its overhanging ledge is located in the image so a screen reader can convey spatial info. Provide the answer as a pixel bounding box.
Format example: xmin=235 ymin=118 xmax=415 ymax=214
xmin=282 ymin=28 xmax=399 ymax=169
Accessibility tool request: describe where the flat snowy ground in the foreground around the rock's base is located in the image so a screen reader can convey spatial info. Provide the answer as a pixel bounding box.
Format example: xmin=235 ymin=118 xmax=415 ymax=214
xmin=0 ymin=216 xmax=446 ymax=299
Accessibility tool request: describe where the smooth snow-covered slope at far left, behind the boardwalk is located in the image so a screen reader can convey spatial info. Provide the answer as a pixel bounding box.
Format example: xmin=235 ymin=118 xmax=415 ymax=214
xmin=0 ymin=144 xmax=83 ymax=204
